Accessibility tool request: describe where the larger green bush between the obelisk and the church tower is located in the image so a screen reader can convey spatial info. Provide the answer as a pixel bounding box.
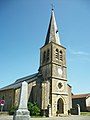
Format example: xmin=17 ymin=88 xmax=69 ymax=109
xmin=28 ymin=102 xmax=41 ymax=116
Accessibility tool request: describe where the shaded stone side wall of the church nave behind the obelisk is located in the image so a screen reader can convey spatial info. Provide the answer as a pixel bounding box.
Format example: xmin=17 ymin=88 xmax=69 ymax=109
xmin=0 ymin=80 xmax=41 ymax=111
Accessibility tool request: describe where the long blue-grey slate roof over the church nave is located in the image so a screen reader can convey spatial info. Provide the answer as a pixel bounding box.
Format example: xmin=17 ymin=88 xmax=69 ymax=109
xmin=0 ymin=73 xmax=38 ymax=91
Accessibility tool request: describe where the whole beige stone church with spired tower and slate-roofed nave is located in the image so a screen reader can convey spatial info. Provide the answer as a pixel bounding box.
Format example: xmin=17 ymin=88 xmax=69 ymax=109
xmin=0 ymin=9 xmax=72 ymax=116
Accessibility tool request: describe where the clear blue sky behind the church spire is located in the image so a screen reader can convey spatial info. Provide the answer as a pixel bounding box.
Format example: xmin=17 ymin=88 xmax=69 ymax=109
xmin=0 ymin=0 xmax=90 ymax=94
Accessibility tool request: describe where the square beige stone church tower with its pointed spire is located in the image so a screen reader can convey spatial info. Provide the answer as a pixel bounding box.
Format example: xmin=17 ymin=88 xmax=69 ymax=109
xmin=39 ymin=9 xmax=70 ymax=116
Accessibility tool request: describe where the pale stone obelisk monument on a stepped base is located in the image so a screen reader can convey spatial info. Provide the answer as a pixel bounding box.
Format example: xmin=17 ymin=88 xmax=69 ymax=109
xmin=13 ymin=81 xmax=30 ymax=120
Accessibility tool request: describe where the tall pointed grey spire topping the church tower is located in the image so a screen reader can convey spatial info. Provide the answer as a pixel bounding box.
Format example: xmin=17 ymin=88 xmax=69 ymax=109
xmin=45 ymin=9 xmax=60 ymax=45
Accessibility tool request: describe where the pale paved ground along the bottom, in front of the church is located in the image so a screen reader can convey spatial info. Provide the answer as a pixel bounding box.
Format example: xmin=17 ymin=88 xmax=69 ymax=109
xmin=0 ymin=115 xmax=90 ymax=120
